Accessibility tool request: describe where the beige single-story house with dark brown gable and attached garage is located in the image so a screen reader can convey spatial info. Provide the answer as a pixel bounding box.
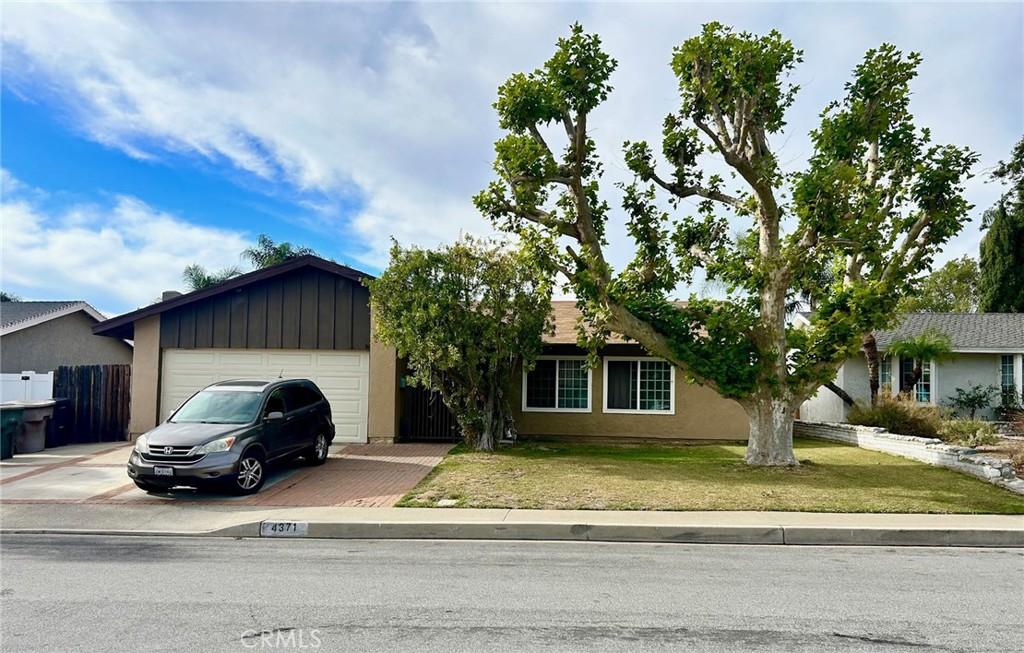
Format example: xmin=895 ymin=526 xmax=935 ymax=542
xmin=93 ymin=256 xmax=748 ymax=442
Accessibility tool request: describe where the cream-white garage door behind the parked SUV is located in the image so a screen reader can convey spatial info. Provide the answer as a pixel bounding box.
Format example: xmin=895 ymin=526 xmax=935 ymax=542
xmin=160 ymin=349 xmax=370 ymax=442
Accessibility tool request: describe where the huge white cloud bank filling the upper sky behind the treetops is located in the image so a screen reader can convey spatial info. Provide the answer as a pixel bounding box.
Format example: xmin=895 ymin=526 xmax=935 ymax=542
xmin=3 ymin=3 xmax=1024 ymax=284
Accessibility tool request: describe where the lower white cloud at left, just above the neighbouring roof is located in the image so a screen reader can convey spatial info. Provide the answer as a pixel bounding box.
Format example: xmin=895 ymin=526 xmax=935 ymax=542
xmin=0 ymin=171 xmax=250 ymax=312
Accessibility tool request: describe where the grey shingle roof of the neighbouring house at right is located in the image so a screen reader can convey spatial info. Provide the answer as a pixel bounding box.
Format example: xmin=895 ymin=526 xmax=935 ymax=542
xmin=874 ymin=313 xmax=1024 ymax=353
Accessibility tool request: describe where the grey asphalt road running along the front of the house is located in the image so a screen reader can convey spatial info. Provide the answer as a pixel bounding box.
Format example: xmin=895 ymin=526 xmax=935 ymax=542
xmin=0 ymin=535 xmax=1024 ymax=653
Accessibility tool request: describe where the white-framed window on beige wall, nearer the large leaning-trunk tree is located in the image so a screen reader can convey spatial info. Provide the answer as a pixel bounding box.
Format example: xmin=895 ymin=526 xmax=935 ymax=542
xmin=604 ymin=356 xmax=676 ymax=415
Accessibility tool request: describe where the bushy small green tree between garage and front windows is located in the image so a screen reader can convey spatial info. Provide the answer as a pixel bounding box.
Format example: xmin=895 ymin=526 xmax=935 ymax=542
xmin=368 ymin=237 xmax=551 ymax=449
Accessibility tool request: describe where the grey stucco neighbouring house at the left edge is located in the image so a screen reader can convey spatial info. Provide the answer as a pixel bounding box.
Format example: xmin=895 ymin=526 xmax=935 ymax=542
xmin=0 ymin=301 xmax=133 ymax=374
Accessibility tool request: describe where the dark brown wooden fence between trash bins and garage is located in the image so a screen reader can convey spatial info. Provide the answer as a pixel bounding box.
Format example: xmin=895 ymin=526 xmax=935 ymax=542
xmin=53 ymin=365 xmax=131 ymax=444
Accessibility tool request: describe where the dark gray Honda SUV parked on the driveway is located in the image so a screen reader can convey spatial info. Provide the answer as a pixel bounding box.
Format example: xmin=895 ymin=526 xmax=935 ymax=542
xmin=128 ymin=379 xmax=334 ymax=494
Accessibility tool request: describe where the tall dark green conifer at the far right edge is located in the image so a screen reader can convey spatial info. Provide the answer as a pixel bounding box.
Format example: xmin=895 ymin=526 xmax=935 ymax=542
xmin=978 ymin=138 xmax=1024 ymax=313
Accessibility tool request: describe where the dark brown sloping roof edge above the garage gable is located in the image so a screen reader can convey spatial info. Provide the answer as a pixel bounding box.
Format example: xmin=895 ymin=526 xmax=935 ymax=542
xmin=92 ymin=254 xmax=373 ymax=339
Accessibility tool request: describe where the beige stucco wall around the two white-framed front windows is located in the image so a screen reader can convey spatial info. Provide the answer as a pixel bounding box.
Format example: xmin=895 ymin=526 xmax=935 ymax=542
xmin=512 ymin=361 xmax=750 ymax=440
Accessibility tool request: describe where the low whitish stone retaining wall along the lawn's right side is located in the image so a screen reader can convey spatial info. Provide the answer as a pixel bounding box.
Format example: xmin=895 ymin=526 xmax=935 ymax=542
xmin=793 ymin=420 xmax=1024 ymax=494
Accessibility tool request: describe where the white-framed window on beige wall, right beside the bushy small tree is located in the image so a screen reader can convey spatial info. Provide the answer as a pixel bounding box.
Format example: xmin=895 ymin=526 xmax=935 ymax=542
xmin=522 ymin=356 xmax=591 ymax=412
